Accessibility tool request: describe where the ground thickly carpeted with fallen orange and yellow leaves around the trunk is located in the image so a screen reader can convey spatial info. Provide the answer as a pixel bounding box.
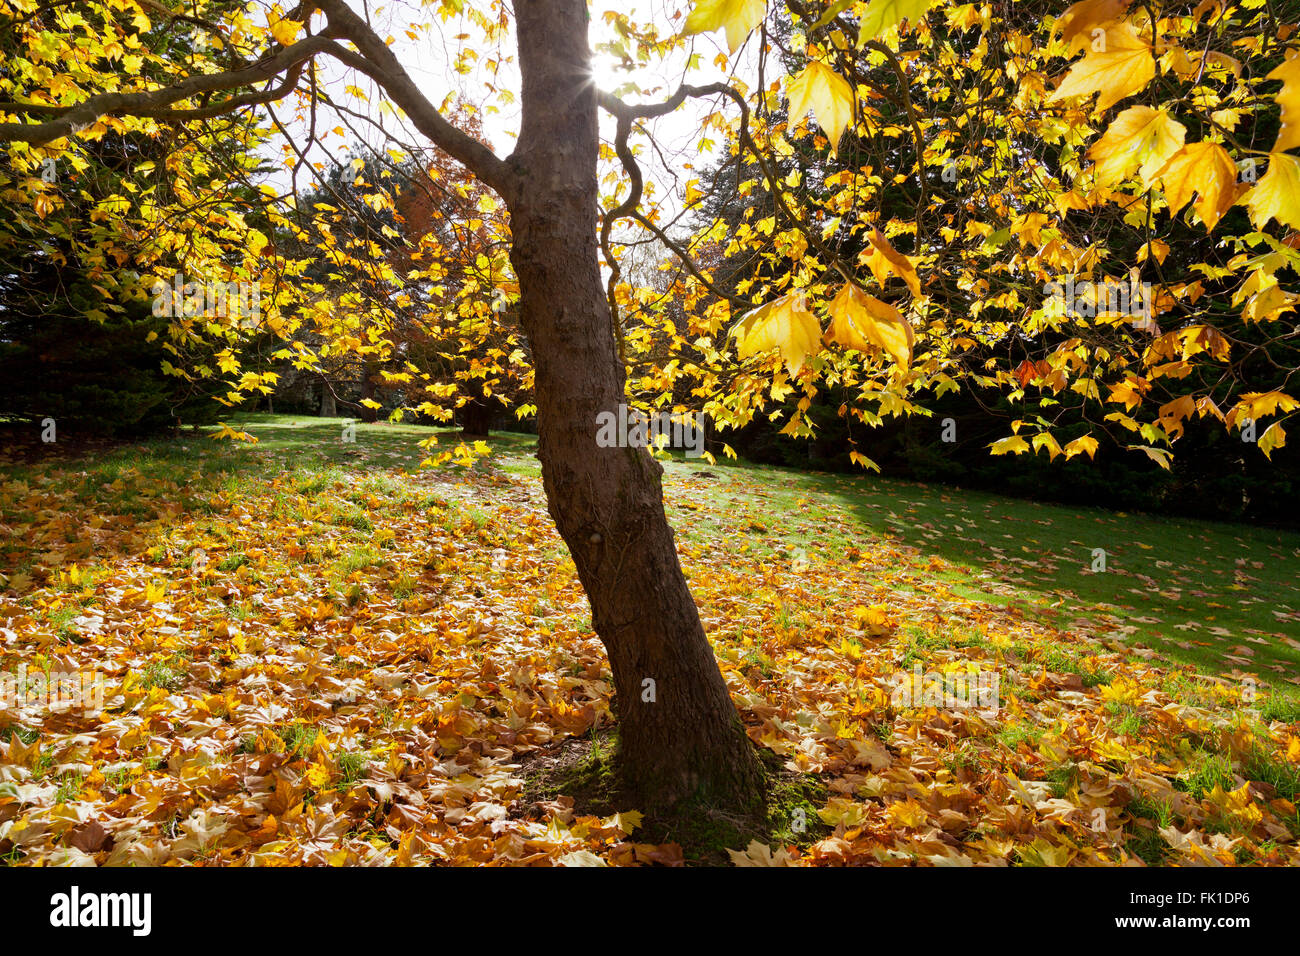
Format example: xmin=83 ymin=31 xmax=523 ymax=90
xmin=0 ymin=419 xmax=1300 ymax=865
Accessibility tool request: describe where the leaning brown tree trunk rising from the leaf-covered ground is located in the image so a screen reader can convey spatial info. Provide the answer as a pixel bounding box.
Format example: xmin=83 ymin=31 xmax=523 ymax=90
xmin=507 ymin=0 xmax=763 ymax=809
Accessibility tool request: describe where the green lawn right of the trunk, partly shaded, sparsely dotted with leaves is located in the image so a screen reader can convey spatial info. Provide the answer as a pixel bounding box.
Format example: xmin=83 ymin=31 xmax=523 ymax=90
xmin=655 ymin=458 xmax=1300 ymax=682
